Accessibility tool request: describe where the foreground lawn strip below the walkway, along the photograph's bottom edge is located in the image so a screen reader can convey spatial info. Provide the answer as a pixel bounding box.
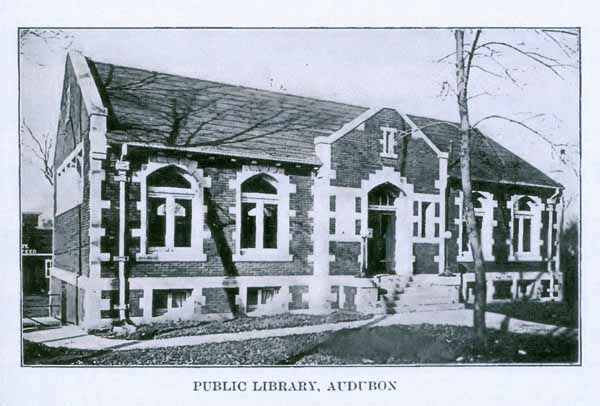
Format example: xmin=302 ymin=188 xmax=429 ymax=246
xmin=25 ymin=324 xmax=578 ymax=365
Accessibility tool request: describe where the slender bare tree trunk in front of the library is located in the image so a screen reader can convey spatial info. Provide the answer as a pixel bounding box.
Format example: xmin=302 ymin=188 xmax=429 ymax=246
xmin=455 ymin=30 xmax=487 ymax=351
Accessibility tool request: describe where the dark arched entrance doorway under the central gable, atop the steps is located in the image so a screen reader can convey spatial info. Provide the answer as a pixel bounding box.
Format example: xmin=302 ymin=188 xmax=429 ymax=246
xmin=367 ymin=182 xmax=403 ymax=276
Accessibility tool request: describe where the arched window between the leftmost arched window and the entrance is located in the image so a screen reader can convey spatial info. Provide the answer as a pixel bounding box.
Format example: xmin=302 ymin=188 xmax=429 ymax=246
xmin=240 ymin=174 xmax=279 ymax=249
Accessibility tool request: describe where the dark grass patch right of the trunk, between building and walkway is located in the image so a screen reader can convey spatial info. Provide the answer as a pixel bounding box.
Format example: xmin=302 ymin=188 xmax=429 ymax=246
xmin=476 ymin=301 xmax=578 ymax=328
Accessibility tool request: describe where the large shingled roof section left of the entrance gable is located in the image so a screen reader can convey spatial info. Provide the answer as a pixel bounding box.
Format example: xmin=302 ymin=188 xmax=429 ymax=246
xmin=88 ymin=59 xmax=367 ymax=165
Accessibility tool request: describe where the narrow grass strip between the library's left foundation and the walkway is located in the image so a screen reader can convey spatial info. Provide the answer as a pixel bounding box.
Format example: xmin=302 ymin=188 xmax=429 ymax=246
xmin=90 ymin=310 xmax=372 ymax=340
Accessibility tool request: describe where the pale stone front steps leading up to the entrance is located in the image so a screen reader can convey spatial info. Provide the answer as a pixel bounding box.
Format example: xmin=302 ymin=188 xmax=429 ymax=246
xmin=378 ymin=275 xmax=464 ymax=314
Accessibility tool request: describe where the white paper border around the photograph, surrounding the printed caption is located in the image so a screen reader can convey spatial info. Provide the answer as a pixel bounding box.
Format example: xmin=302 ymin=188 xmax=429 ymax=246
xmin=0 ymin=7 xmax=600 ymax=406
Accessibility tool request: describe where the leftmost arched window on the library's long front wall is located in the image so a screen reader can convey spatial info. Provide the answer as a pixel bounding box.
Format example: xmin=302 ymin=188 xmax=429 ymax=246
xmin=146 ymin=166 xmax=194 ymax=251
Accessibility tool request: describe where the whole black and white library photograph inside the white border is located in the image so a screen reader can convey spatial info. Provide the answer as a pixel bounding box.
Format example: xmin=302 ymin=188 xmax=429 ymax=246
xmin=18 ymin=27 xmax=582 ymax=367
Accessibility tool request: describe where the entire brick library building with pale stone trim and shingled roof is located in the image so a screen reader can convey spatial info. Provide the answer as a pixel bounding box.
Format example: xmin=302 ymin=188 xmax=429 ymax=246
xmin=50 ymin=53 xmax=562 ymax=327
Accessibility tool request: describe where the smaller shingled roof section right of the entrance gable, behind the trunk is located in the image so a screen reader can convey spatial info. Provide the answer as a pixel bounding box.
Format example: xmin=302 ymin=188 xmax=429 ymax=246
xmin=409 ymin=115 xmax=562 ymax=187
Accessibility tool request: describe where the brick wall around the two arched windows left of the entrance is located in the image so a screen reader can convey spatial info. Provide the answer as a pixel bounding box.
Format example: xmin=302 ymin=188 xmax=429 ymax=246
xmin=101 ymin=148 xmax=312 ymax=277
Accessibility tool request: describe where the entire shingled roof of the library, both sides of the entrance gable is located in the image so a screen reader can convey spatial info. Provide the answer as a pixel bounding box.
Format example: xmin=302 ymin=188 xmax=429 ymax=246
xmin=87 ymin=59 xmax=561 ymax=187
